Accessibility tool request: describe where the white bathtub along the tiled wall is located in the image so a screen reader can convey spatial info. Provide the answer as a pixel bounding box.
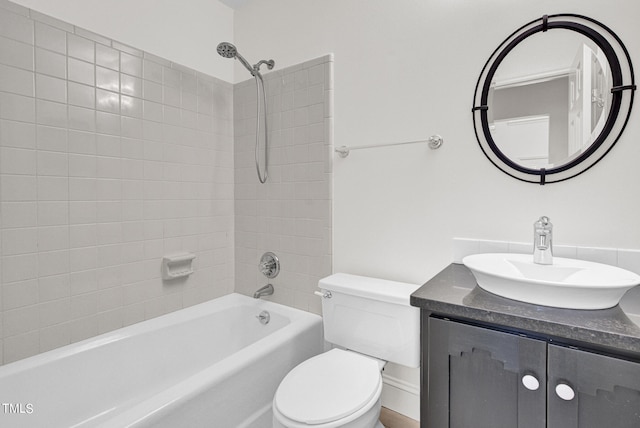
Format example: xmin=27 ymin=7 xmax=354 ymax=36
xmin=0 ymin=294 xmax=323 ymax=428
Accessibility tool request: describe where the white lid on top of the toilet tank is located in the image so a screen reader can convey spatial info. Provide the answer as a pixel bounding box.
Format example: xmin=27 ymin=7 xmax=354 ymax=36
xmin=318 ymin=273 xmax=420 ymax=306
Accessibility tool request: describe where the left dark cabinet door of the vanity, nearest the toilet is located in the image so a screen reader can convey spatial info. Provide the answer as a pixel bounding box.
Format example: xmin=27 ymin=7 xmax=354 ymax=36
xmin=427 ymin=318 xmax=547 ymax=428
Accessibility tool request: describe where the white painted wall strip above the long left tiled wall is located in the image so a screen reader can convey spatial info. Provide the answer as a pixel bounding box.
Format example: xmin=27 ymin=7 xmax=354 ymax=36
xmin=8 ymin=0 xmax=234 ymax=82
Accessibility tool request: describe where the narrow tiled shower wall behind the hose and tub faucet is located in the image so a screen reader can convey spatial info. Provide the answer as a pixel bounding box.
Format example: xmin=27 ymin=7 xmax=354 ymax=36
xmin=234 ymin=55 xmax=333 ymax=313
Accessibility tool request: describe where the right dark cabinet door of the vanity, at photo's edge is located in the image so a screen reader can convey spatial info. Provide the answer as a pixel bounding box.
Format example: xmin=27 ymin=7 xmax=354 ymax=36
xmin=548 ymin=345 xmax=640 ymax=428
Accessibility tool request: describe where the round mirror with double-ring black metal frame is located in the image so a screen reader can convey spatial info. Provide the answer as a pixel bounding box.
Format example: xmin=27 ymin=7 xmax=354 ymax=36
xmin=473 ymin=14 xmax=635 ymax=184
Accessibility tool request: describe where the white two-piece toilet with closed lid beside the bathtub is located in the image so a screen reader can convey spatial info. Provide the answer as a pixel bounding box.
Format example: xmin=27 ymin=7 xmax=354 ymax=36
xmin=272 ymin=273 xmax=420 ymax=428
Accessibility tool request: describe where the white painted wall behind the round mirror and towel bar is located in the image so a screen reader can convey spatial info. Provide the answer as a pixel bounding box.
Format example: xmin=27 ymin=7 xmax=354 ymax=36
xmin=235 ymin=0 xmax=640 ymax=283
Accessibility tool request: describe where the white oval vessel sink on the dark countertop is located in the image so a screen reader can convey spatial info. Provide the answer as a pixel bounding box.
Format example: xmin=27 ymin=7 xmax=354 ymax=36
xmin=462 ymin=254 xmax=640 ymax=309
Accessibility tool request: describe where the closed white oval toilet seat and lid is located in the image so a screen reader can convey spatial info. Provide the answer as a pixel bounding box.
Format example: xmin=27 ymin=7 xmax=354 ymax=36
xmin=273 ymin=349 xmax=382 ymax=425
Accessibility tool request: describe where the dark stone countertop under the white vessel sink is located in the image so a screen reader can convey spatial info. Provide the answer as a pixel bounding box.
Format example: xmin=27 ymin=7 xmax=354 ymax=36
xmin=411 ymin=264 xmax=640 ymax=359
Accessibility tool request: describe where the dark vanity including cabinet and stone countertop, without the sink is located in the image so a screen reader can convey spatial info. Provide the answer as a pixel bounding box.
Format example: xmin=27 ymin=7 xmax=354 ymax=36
xmin=411 ymin=264 xmax=640 ymax=428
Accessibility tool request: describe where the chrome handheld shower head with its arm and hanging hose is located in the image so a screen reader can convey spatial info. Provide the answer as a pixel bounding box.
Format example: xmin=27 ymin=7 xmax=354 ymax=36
xmin=217 ymin=42 xmax=275 ymax=184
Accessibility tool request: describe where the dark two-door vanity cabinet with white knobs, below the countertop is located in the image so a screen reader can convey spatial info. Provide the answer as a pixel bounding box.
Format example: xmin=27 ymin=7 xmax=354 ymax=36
xmin=422 ymin=316 xmax=640 ymax=428
